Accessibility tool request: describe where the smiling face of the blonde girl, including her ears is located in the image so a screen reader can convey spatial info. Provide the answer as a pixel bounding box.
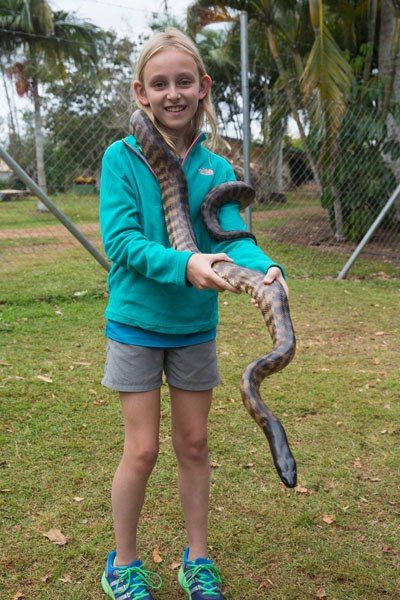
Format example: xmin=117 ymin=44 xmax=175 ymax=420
xmin=133 ymin=47 xmax=211 ymax=140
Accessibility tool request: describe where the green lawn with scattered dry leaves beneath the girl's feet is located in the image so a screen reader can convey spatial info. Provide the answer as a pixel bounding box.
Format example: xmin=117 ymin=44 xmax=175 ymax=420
xmin=0 ymin=244 xmax=400 ymax=600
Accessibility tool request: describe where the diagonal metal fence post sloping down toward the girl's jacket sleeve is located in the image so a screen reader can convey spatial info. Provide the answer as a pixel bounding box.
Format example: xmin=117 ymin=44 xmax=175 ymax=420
xmin=0 ymin=146 xmax=110 ymax=271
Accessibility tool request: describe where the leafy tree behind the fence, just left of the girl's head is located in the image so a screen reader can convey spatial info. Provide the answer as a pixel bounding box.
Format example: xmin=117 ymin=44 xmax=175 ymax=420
xmin=44 ymin=32 xmax=136 ymax=190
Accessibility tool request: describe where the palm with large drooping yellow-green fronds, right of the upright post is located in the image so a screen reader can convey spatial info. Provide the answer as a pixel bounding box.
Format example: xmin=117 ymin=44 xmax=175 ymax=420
xmin=190 ymin=0 xmax=353 ymax=238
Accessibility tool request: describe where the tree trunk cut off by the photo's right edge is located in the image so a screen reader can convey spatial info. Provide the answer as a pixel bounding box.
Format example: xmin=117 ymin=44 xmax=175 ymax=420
xmin=378 ymin=0 xmax=400 ymax=223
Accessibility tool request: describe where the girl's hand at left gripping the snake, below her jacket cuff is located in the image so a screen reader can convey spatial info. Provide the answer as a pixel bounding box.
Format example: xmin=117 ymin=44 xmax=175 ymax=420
xmin=186 ymin=253 xmax=240 ymax=294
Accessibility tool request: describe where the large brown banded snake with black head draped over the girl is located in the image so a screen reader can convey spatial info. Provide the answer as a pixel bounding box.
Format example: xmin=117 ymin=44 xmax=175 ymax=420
xmin=130 ymin=110 xmax=297 ymax=487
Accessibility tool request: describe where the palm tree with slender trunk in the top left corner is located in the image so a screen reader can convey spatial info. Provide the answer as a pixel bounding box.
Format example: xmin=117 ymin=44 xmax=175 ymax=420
xmin=0 ymin=0 xmax=102 ymax=210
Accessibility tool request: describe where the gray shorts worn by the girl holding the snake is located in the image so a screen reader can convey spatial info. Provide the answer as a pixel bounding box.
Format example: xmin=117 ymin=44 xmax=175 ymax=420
xmin=101 ymin=338 xmax=220 ymax=392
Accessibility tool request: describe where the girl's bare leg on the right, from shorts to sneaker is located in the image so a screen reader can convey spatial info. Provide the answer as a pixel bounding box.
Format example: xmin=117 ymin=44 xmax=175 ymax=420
xmin=170 ymin=386 xmax=212 ymax=560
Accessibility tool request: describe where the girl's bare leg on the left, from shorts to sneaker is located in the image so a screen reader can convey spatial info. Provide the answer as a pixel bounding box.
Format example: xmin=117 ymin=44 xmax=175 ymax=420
xmin=111 ymin=389 xmax=160 ymax=565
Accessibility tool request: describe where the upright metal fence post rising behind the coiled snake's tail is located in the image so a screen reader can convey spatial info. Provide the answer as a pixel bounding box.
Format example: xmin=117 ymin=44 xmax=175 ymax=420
xmin=240 ymin=11 xmax=252 ymax=231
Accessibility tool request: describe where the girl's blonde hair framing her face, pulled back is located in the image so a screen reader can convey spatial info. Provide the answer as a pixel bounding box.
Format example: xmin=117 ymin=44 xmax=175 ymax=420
xmin=135 ymin=27 xmax=218 ymax=150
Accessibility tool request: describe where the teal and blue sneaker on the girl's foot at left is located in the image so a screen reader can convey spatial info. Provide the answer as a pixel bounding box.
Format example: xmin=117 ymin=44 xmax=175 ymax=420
xmin=101 ymin=550 xmax=162 ymax=600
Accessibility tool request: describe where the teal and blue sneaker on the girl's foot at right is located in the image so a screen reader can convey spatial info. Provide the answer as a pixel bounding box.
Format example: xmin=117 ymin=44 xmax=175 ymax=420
xmin=178 ymin=548 xmax=224 ymax=600
